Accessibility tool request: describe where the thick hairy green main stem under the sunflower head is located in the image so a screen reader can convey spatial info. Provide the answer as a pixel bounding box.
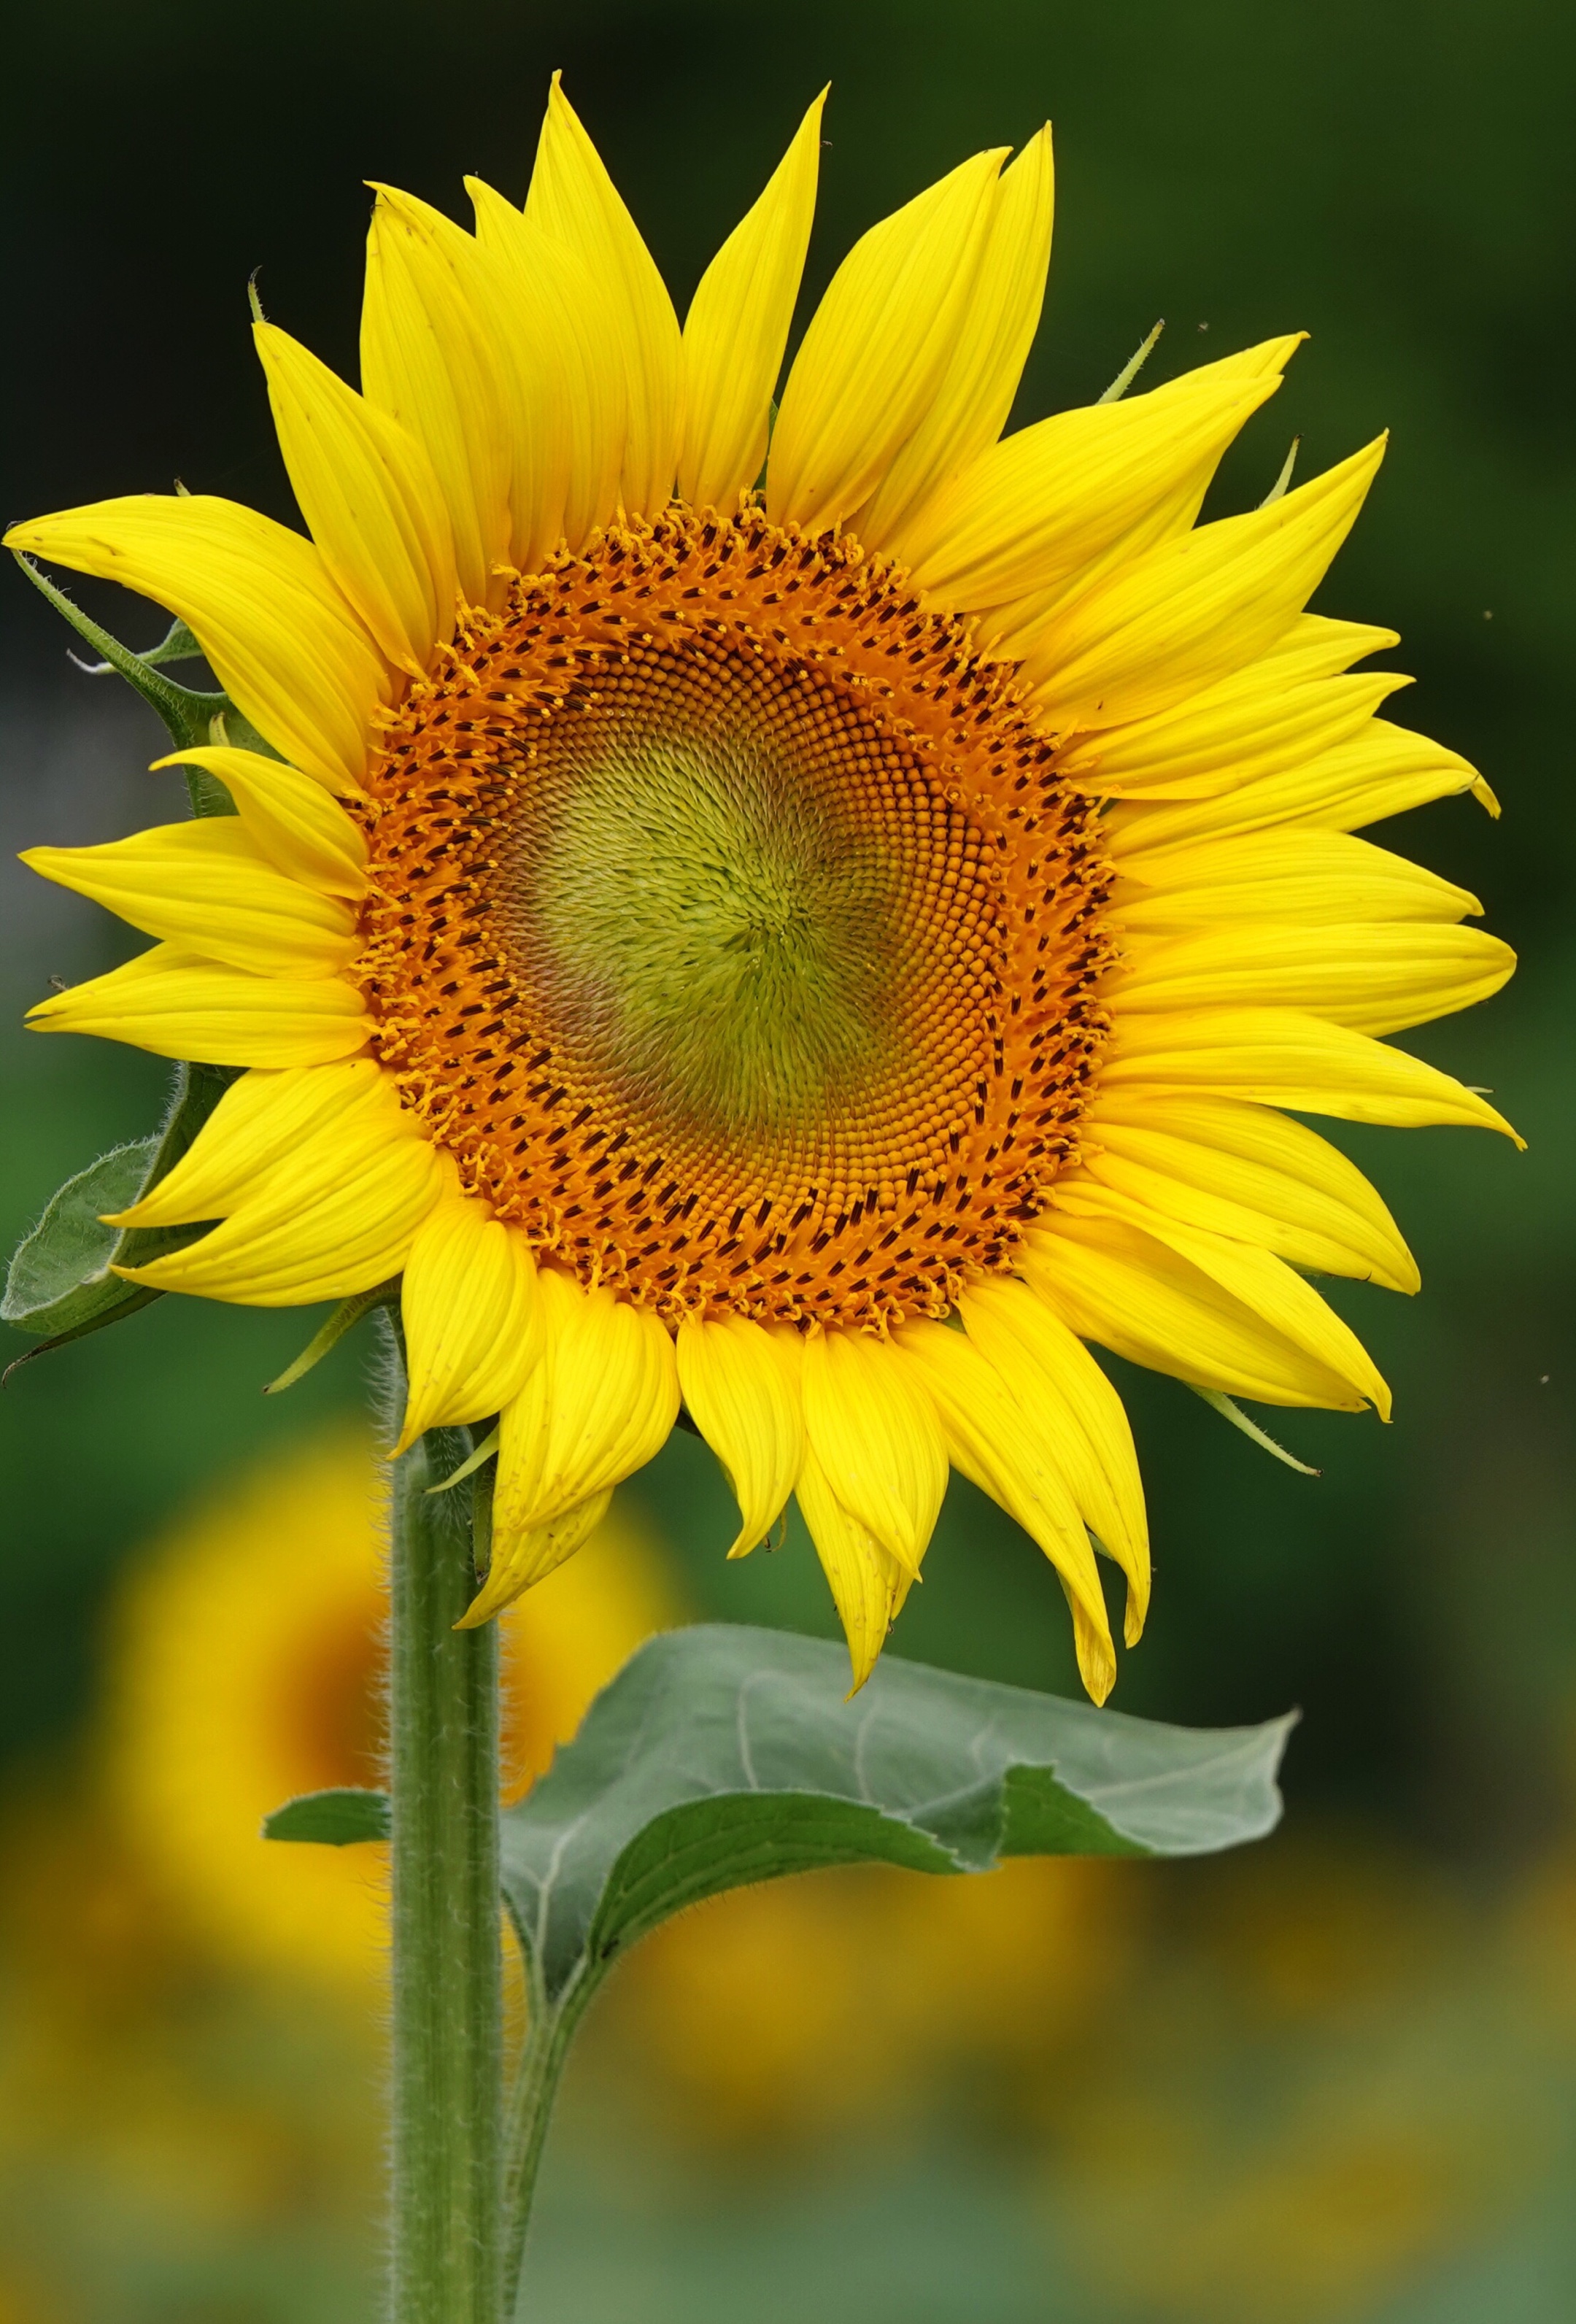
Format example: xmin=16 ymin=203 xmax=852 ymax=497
xmin=388 ymin=1394 xmax=504 ymax=2324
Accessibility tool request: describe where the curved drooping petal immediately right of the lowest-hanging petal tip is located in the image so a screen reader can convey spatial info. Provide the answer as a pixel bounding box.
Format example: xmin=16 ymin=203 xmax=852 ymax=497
xmin=958 ymin=1276 xmax=1151 ymax=1645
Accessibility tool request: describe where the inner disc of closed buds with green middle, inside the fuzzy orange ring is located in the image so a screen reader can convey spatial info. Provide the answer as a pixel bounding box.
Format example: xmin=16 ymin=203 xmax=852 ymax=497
xmin=488 ymin=641 xmax=995 ymax=1206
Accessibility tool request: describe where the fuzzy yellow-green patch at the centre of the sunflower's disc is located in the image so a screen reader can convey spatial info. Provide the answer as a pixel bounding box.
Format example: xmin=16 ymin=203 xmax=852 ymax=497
xmin=504 ymin=732 xmax=906 ymax=1159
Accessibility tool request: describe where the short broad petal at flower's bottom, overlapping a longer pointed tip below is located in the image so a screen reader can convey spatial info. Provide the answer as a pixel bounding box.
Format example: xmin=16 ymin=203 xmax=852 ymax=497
xmin=802 ymin=1329 xmax=946 ymax=1573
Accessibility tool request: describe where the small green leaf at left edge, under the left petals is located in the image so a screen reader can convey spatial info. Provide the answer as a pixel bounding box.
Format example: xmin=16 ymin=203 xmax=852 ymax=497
xmin=0 ymin=1065 xmax=235 ymax=1371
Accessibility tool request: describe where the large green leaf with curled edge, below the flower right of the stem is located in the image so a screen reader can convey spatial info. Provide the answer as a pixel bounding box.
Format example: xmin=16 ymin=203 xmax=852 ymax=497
xmin=502 ymin=1624 xmax=1290 ymax=2006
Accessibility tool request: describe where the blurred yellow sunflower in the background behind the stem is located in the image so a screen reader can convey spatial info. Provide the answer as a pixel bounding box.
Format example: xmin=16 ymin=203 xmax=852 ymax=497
xmin=102 ymin=1429 xmax=679 ymax=1983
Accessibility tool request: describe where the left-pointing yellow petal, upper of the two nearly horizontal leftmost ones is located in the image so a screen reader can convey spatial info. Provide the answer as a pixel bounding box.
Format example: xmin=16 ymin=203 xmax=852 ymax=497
xmin=21 ymin=816 xmax=360 ymax=976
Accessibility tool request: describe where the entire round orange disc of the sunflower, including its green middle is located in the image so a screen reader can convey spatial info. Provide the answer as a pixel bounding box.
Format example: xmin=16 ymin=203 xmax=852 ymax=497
xmin=358 ymin=509 xmax=1111 ymax=1329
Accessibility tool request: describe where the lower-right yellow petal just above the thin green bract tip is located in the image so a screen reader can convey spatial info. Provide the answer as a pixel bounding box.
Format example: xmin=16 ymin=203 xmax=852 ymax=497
xmin=1023 ymin=1213 xmax=1383 ymax=1413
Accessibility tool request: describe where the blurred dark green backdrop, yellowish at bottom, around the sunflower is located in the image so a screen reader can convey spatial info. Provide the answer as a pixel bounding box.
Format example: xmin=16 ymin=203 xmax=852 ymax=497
xmin=0 ymin=0 xmax=1576 ymax=2324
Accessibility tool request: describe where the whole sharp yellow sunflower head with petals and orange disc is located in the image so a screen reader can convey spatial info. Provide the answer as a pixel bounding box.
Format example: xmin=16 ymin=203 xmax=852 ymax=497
xmin=7 ymin=84 xmax=1511 ymax=1699
